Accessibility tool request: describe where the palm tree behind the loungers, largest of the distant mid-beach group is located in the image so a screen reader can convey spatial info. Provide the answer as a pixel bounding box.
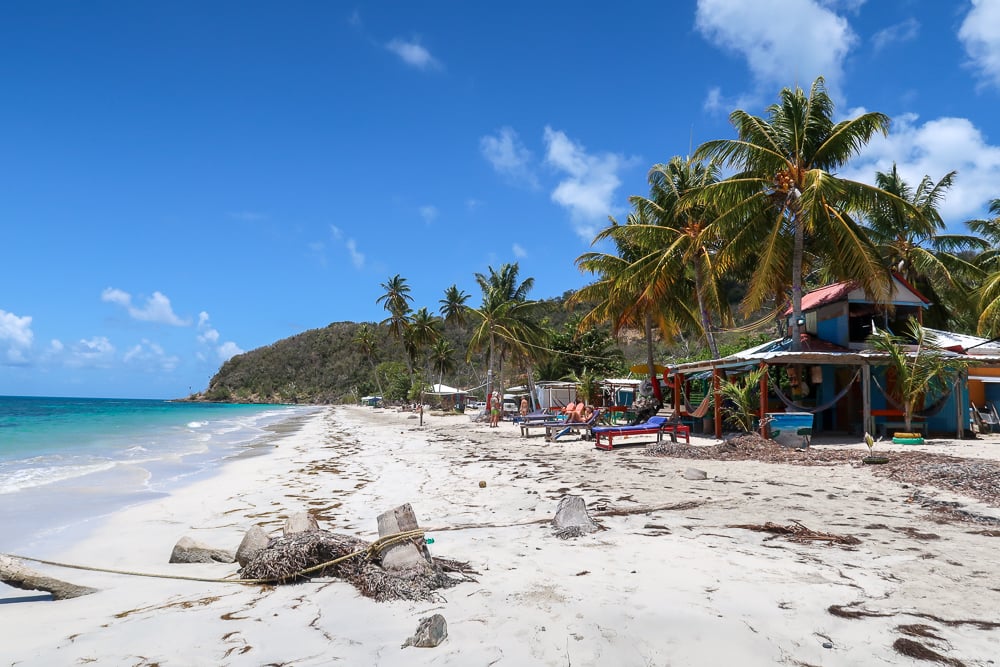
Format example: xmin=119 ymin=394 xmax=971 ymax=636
xmin=466 ymin=262 xmax=545 ymax=404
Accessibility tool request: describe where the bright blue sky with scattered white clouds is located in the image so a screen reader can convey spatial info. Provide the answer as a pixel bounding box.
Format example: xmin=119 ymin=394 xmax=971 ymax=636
xmin=0 ymin=0 xmax=1000 ymax=398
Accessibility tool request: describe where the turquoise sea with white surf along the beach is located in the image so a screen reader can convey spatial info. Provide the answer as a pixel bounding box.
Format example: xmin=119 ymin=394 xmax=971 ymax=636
xmin=0 ymin=396 xmax=316 ymax=556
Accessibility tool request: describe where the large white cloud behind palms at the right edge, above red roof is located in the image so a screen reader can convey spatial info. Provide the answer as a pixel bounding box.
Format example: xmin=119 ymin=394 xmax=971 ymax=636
xmin=842 ymin=114 xmax=1000 ymax=222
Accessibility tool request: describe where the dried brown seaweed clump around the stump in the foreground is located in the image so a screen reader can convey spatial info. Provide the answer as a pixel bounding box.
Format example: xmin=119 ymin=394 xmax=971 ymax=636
xmin=240 ymin=530 xmax=477 ymax=602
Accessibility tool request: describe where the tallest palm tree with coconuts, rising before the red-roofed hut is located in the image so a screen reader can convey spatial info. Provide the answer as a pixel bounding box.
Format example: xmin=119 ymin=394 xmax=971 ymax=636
xmin=694 ymin=77 xmax=912 ymax=350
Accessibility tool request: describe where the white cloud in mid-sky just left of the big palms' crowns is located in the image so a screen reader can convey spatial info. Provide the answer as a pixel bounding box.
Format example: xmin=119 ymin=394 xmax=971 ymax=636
xmin=544 ymin=127 xmax=635 ymax=241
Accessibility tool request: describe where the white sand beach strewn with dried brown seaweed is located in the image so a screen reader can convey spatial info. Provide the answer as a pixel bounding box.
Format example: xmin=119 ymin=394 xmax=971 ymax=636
xmin=0 ymin=407 xmax=1000 ymax=666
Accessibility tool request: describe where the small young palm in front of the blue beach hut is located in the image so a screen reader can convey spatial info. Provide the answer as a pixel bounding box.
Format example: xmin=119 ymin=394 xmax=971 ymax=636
xmin=868 ymin=318 xmax=968 ymax=431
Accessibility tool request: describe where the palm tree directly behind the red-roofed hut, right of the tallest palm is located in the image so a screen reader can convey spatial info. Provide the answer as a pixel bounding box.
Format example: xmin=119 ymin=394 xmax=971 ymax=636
xmin=866 ymin=164 xmax=988 ymax=329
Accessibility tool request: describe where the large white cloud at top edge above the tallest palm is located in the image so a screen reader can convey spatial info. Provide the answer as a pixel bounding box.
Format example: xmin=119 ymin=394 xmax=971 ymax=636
xmin=695 ymin=0 xmax=858 ymax=99
